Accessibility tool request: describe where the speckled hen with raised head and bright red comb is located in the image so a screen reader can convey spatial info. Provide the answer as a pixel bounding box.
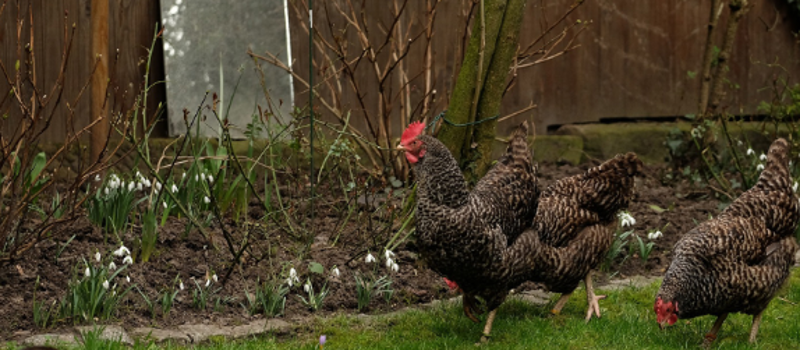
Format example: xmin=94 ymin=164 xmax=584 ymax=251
xmin=398 ymin=122 xmax=538 ymax=340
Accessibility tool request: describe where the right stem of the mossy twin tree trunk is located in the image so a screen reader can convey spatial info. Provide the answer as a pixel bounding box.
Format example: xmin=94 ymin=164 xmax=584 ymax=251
xmin=462 ymin=0 xmax=526 ymax=179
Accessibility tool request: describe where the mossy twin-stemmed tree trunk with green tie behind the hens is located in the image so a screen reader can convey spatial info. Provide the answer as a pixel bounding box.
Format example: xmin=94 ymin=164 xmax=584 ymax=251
xmin=439 ymin=0 xmax=526 ymax=180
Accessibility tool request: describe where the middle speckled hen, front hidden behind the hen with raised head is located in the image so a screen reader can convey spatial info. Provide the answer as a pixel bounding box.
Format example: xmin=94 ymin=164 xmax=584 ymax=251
xmin=514 ymin=153 xmax=643 ymax=321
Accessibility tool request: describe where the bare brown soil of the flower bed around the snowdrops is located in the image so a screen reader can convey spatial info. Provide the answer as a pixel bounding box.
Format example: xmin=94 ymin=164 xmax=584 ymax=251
xmin=0 ymin=164 xmax=720 ymax=340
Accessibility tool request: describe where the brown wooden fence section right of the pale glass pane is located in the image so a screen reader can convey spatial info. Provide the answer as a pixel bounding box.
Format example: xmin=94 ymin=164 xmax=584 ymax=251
xmin=292 ymin=0 xmax=800 ymax=134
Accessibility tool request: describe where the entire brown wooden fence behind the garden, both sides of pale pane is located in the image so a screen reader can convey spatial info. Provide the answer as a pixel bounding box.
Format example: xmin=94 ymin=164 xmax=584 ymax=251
xmin=0 ymin=0 xmax=800 ymax=141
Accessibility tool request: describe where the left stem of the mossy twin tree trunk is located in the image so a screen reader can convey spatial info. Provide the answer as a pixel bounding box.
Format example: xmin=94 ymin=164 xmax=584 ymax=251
xmin=438 ymin=0 xmax=506 ymax=164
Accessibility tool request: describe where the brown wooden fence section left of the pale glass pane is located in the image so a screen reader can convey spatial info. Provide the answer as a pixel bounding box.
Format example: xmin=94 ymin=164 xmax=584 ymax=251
xmin=0 ymin=0 xmax=166 ymax=142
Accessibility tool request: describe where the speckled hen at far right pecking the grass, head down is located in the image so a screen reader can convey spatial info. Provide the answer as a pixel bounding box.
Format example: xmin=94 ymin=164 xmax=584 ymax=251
xmin=654 ymin=139 xmax=800 ymax=345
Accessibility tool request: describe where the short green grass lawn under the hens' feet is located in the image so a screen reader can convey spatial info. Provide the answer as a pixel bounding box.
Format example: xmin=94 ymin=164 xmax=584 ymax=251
xmin=20 ymin=269 xmax=800 ymax=350
